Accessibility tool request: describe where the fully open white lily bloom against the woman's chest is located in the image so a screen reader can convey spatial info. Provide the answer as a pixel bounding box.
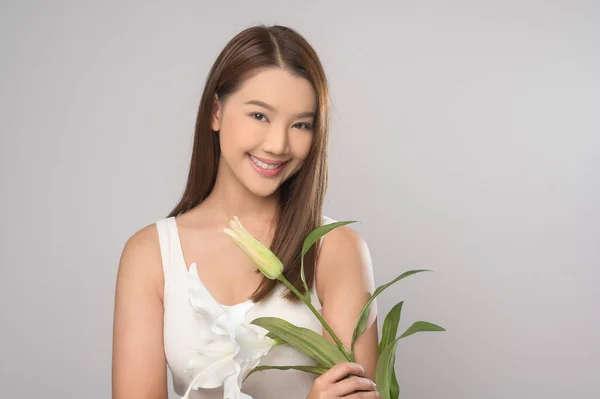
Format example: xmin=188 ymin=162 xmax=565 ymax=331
xmin=182 ymin=263 xmax=274 ymax=399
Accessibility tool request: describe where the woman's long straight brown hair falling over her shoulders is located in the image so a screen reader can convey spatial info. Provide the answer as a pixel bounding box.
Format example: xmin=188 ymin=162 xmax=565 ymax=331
xmin=169 ymin=25 xmax=329 ymax=301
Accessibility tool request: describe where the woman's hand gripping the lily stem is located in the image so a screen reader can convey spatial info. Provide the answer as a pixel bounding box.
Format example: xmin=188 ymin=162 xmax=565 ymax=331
xmin=306 ymin=363 xmax=379 ymax=399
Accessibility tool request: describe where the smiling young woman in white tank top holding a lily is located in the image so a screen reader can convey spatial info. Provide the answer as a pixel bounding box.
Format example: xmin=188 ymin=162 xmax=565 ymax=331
xmin=113 ymin=26 xmax=378 ymax=399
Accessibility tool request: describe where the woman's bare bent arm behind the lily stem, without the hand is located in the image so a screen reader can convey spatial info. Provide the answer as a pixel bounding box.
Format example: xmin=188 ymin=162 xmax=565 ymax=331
xmin=317 ymin=226 xmax=378 ymax=381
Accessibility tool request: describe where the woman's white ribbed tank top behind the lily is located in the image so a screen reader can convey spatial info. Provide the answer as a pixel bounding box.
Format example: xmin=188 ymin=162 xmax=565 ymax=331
xmin=156 ymin=216 xmax=331 ymax=399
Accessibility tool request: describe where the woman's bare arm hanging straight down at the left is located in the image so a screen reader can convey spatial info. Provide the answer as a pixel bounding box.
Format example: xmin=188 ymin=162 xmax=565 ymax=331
xmin=112 ymin=225 xmax=167 ymax=399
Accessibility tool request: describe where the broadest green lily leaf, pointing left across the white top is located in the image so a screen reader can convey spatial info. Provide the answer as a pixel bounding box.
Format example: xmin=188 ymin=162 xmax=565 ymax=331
xmin=252 ymin=317 xmax=347 ymax=369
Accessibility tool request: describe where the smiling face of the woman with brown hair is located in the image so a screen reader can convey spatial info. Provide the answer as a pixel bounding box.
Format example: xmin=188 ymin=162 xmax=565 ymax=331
xmin=212 ymin=68 xmax=317 ymax=200
